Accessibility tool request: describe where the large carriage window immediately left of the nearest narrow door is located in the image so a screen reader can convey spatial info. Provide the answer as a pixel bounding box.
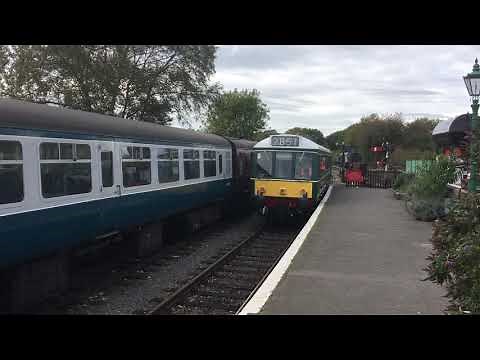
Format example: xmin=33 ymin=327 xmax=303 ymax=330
xmin=40 ymin=142 xmax=92 ymax=198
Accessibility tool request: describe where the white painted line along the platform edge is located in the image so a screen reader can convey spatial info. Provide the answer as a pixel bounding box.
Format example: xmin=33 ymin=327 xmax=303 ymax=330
xmin=238 ymin=186 xmax=333 ymax=315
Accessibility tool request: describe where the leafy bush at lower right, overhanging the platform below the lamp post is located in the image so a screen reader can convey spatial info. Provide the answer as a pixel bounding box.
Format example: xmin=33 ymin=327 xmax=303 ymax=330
xmin=426 ymin=194 xmax=480 ymax=314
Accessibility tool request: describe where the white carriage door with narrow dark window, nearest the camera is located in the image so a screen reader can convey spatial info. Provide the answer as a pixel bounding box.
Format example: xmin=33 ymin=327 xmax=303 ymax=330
xmin=98 ymin=143 xmax=120 ymax=197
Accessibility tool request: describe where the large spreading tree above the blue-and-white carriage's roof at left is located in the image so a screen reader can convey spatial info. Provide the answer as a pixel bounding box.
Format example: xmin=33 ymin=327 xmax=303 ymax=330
xmin=0 ymin=45 xmax=219 ymax=124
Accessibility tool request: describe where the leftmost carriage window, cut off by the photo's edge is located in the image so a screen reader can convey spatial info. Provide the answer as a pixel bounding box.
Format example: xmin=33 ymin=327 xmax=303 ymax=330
xmin=0 ymin=140 xmax=23 ymax=205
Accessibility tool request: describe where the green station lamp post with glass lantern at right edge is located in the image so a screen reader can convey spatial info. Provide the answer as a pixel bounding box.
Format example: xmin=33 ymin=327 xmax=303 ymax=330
xmin=463 ymin=59 xmax=480 ymax=192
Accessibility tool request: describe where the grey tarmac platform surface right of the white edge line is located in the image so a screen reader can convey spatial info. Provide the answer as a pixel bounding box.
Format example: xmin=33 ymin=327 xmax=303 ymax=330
xmin=259 ymin=185 xmax=448 ymax=315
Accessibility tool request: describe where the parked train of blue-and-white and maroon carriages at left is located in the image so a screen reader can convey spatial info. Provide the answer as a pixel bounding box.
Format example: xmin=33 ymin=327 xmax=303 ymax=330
xmin=0 ymin=99 xmax=253 ymax=268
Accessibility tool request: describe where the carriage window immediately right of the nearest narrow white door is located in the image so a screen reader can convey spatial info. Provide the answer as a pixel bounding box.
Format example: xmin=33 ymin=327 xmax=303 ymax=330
xmin=121 ymin=146 xmax=152 ymax=187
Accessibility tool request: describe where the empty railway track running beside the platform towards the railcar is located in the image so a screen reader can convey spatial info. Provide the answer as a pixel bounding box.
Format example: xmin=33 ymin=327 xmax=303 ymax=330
xmin=149 ymin=225 xmax=301 ymax=315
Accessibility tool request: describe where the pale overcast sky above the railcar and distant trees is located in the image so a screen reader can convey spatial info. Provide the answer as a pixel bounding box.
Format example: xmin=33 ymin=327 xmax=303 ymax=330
xmin=206 ymin=45 xmax=480 ymax=135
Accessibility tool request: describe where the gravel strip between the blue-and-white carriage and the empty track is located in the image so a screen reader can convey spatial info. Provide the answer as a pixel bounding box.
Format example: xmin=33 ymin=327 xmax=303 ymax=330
xmin=29 ymin=214 xmax=263 ymax=314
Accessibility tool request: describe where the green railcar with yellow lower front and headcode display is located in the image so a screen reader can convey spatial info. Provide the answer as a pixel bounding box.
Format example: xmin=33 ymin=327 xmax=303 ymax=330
xmin=252 ymin=135 xmax=332 ymax=216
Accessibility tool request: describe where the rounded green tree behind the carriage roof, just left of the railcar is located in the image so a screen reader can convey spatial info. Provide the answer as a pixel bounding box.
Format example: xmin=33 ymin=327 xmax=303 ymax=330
xmin=204 ymin=89 xmax=269 ymax=140
